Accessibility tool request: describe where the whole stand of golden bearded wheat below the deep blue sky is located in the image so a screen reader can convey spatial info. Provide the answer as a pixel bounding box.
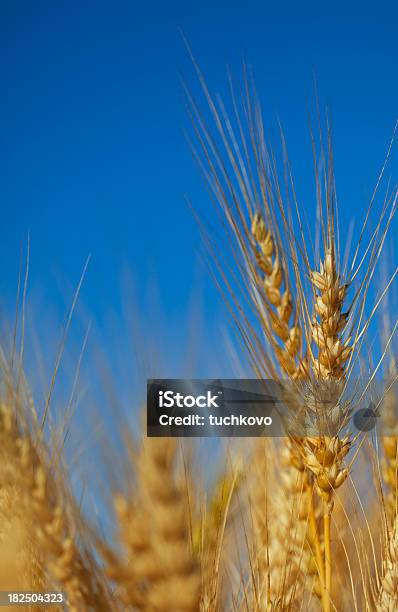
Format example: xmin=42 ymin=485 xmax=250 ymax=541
xmin=0 ymin=69 xmax=398 ymax=612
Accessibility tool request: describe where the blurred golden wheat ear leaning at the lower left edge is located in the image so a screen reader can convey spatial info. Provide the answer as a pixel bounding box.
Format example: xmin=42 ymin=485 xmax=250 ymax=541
xmin=0 ymin=402 xmax=111 ymax=611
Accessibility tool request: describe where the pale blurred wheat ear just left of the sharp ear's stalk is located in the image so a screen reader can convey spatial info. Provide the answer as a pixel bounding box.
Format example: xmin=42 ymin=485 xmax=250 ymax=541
xmin=249 ymin=440 xmax=312 ymax=611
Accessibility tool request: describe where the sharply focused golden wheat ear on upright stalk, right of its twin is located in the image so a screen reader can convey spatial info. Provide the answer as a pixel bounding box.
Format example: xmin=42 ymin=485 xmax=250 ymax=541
xmin=303 ymin=245 xmax=352 ymax=612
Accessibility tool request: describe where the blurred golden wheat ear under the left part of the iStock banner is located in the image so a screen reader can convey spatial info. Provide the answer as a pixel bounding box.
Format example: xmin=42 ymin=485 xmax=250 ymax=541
xmin=104 ymin=438 xmax=200 ymax=612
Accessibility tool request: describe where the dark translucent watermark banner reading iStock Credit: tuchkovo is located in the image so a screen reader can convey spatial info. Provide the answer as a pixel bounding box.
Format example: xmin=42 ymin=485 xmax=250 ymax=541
xmin=147 ymin=379 xmax=388 ymax=437
